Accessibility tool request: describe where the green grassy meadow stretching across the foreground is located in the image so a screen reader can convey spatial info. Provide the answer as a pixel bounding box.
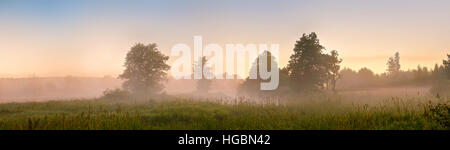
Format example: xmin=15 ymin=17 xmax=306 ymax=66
xmin=0 ymin=96 xmax=450 ymax=130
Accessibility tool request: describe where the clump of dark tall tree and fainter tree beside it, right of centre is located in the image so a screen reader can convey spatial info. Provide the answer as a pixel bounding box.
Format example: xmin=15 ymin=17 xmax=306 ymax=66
xmin=239 ymin=32 xmax=342 ymax=96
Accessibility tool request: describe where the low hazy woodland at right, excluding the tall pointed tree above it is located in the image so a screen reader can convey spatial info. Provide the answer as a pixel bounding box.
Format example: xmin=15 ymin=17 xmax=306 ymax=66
xmin=337 ymin=53 xmax=450 ymax=89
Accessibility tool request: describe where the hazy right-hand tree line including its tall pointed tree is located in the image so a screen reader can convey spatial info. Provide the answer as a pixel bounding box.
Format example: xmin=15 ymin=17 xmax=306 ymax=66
xmin=338 ymin=52 xmax=450 ymax=88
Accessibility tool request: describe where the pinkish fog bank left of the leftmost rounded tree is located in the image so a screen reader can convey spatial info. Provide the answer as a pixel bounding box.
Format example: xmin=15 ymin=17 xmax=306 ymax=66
xmin=0 ymin=76 xmax=122 ymax=102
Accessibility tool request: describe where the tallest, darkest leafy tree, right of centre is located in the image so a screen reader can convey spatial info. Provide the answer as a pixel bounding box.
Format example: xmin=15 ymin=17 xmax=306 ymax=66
xmin=287 ymin=32 xmax=341 ymax=90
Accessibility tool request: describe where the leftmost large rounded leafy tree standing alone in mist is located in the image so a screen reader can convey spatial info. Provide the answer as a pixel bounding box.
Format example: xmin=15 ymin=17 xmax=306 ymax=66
xmin=119 ymin=43 xmax=170 ymax=97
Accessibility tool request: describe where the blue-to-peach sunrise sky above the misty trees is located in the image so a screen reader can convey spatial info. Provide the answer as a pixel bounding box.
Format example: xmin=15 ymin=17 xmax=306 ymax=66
xmin=0 ymin=0 xmax=450 ymax=77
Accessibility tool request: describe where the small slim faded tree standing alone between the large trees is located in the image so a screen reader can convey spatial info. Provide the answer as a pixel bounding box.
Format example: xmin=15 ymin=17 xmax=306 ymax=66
xmin=194 ymin=56 xmax=212 ymax=93
